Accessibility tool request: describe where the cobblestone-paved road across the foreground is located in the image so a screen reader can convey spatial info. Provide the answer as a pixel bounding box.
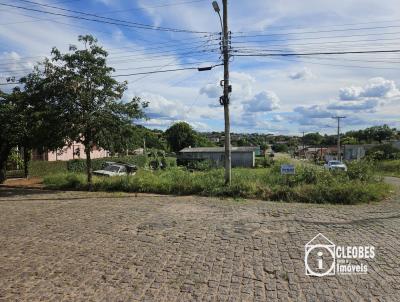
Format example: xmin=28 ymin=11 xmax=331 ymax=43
xmin=0 ymin=183 xmax=400 ymax=301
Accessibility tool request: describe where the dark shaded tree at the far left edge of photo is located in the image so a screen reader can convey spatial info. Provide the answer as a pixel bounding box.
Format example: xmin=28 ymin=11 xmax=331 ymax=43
xmin=0 ymin=72 xmax=70 ymax=182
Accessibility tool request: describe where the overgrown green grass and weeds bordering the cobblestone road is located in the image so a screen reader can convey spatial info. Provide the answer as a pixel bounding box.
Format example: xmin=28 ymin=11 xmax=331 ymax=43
xmin=44 ymin=163 xmax=390 ymax=204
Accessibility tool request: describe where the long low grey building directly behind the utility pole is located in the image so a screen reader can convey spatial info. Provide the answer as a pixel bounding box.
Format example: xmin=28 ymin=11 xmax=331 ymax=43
xmin=178 ymin=147 xmax=256 ymax=168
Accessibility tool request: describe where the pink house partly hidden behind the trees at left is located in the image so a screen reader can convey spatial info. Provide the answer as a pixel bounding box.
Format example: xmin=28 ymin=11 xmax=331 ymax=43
xmin=32 ymin=142 xmax=110 ymax=161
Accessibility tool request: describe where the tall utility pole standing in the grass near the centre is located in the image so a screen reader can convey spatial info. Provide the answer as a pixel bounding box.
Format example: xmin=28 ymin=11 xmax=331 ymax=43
xmin=222 ymin=0 xmax=232 ymax=185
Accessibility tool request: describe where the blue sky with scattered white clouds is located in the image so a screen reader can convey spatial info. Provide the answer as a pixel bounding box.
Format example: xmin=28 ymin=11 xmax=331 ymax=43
xmin=0 ymin=0 xmax=400 ymax=135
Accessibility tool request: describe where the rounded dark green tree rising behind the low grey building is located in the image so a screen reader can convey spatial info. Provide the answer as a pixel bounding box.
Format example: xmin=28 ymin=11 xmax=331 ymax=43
xmin=165 ymin=122 xmax=196 ymax=152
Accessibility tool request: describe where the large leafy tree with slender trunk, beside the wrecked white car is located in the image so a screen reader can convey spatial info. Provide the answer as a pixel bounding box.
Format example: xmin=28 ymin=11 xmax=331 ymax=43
xmin=36 ymin=35 xmax=147 ymax=190
